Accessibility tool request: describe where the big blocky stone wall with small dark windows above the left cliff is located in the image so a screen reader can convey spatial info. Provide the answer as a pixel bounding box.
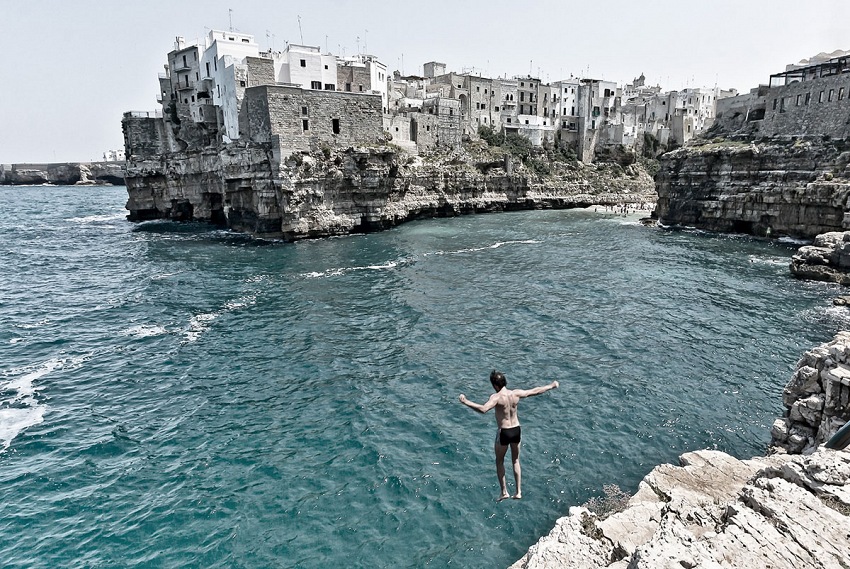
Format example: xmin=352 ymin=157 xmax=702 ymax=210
xmin=244 ymin=86 xmax=383 ymax=156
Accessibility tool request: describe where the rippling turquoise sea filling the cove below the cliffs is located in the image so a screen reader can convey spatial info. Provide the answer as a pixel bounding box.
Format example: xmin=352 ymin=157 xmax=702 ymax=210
xmin=0 ymin=187 xmax=850 ymax=568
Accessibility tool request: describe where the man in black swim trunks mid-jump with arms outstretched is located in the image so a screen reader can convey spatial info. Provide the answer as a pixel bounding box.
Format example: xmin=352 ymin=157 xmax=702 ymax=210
xmin=459 ymin=370 xmax=558 ymax=502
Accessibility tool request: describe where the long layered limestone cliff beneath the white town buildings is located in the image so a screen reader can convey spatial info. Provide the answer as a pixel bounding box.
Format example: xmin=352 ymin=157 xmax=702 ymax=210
xmin=127 ymin=143 xmax=655 ymax=239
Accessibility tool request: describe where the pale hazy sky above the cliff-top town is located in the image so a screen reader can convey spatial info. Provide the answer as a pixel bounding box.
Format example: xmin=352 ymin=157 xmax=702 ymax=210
xmin=0 ymin=0 xmax=850 ymax=164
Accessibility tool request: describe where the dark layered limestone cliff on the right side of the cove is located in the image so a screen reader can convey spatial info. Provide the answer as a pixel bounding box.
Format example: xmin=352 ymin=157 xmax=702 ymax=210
xmin=654 ymin=137 xmax=850 ymax=238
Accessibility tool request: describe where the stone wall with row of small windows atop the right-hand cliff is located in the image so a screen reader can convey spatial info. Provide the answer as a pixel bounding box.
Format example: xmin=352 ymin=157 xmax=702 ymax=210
xmin=759 ymin=75 xmax=850 ymax=138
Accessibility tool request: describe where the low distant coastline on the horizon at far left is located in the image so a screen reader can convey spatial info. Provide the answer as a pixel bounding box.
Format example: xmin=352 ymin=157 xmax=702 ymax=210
xmin=0 ymin=161 xmax=126 ymax=186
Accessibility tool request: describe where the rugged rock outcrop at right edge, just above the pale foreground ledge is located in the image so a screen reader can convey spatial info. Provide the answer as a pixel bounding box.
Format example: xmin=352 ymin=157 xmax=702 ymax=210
xmin=771 ymin=332 xmax=850 ymax=453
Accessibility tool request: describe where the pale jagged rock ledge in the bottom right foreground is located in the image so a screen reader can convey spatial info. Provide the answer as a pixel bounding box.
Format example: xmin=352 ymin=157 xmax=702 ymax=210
xmin=511 ymin=449 xmax=850 ymax=569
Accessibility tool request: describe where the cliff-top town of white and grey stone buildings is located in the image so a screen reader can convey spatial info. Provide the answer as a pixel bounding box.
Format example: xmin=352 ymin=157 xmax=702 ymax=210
xmin=125 ymin=30 xmax=850 ymax=162
